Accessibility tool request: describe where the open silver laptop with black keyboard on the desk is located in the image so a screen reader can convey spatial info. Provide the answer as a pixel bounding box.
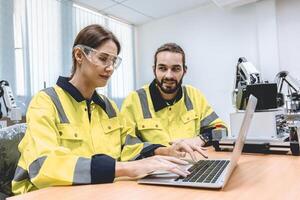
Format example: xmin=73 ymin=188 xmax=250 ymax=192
xmin=138 ymin=95 xmax=257 ymax=189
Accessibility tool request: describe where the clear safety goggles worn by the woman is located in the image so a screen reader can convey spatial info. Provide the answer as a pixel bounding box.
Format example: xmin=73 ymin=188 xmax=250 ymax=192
xmin=74 ymin=44 xmax=122 ymax=70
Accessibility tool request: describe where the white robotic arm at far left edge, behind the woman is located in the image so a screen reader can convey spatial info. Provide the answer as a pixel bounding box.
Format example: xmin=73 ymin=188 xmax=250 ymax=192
xmin=0 ymin=80 xmax=22 ymax=121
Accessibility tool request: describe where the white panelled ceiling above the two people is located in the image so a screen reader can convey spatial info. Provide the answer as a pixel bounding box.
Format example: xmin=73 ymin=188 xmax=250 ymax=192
xmin=73 ymin=0 xmax=257 ymax=25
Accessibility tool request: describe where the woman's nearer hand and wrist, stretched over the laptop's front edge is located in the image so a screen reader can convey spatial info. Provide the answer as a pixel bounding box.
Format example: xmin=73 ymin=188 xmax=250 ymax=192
xmin=115 ymin=156 xmax=190 ymax=177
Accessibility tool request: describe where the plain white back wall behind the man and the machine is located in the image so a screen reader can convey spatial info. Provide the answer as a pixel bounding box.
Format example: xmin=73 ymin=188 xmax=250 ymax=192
xmin=136 ymin=0 xmax=300 ymax=124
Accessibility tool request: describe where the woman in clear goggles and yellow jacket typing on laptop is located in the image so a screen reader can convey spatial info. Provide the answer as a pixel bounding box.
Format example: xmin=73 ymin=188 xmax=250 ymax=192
xmin=12 ymin=25 xmax=188 ymax=194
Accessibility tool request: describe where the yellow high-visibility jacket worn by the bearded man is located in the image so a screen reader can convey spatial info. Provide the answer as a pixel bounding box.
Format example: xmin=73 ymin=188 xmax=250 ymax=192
xmin=121 ymin=81 xmax=226 ymax=159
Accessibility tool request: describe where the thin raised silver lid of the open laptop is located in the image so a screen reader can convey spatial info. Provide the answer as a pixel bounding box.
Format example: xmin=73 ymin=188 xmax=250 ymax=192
xmin=223 ymin=95 xmax=257 ymax=187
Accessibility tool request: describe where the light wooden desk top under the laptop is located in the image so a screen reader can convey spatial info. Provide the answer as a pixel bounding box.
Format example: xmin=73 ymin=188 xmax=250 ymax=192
xmin=9 ymin=152 xmax=300 ymax=200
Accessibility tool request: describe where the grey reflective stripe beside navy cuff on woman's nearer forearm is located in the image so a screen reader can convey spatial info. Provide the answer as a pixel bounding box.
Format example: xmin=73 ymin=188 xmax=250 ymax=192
xmin=73 ymin=157 xmax=91 ymax=185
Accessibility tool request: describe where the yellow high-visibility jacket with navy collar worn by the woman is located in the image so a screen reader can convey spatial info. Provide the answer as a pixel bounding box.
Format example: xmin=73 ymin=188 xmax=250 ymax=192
xmin=12 ymin=77 xmax=123 ymax=194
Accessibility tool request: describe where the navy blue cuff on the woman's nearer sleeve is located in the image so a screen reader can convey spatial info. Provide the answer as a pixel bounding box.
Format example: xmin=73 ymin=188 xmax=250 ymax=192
xmin=91 ymin=154 xmax=116 ymax=184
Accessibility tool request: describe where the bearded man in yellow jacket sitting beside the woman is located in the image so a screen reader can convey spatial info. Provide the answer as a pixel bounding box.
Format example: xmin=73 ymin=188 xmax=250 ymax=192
xmin=121 ymin=43 xmax=226 ymax=162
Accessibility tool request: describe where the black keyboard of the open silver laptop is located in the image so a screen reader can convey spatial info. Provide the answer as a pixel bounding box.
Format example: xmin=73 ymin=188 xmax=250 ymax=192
xmin=177 ymin=160 xmax=229 ymax=183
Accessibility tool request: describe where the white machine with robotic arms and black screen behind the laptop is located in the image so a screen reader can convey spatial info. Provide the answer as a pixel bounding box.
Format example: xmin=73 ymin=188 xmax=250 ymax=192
xmin=213 ymin=58 xmax=300 ymax=155
